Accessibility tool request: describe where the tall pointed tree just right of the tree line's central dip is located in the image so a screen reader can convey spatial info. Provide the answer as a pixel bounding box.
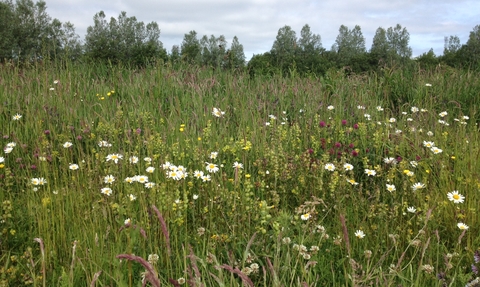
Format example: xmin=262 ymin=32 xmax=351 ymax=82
xmin=270 ymin=26 xmax=297 ymax=71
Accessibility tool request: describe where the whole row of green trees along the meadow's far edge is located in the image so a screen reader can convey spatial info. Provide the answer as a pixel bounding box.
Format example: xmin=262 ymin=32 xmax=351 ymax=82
xmin=0 ymin=0 xmax=480 ymax=76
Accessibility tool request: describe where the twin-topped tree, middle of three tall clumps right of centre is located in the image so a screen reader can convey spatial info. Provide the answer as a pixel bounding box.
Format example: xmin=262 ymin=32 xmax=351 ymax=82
xmin=332 ymin=25 xmax=366 ymax=65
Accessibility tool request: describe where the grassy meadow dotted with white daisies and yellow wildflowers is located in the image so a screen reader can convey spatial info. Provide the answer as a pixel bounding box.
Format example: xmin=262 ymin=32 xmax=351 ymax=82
xmin=0 ymin=63 xmax=480 ymax=287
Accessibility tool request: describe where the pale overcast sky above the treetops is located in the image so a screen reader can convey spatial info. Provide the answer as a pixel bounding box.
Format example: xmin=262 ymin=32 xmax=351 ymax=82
xmin=45 ymin=0 xmax=480 ymax=60
